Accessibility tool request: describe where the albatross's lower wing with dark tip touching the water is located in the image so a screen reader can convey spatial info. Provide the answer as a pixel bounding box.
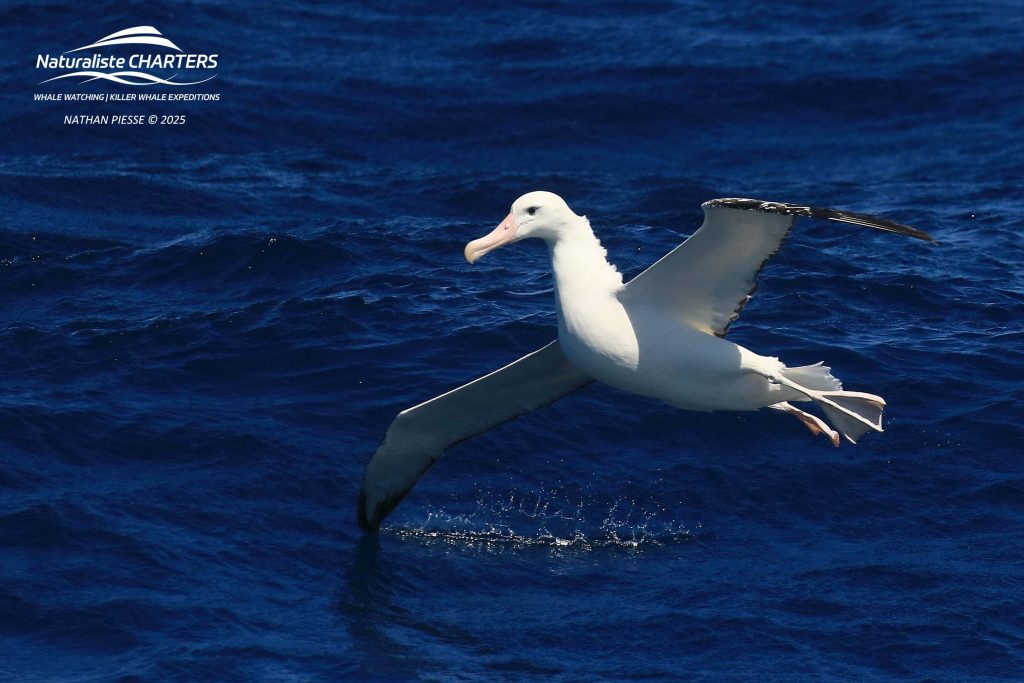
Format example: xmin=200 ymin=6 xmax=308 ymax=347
xmin=357 ymin=341 xmax=593 ymax=531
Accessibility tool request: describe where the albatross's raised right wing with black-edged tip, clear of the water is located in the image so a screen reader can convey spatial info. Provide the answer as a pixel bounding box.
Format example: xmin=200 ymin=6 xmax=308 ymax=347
xmin=621 ymin=199 xmax=933 ymax=337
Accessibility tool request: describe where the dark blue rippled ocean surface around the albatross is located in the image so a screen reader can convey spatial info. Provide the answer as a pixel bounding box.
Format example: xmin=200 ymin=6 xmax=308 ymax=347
xmin=0 ymin=0 xmax=1024 ymax=682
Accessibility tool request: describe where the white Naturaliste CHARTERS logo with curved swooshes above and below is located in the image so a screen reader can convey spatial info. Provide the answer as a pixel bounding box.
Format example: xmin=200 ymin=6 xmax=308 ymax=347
xmin=36 ymin=26 xmax=218 ymax=86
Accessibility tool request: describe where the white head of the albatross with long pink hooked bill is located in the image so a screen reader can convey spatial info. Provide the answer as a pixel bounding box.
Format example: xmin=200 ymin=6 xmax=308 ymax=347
xmin=464 ymin=191 xmax=582 ymax=263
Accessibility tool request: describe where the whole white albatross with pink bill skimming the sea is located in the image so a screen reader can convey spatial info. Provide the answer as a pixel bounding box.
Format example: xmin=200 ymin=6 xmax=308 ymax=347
xmin=357 ymin=191 xmax=932 ymax=531
